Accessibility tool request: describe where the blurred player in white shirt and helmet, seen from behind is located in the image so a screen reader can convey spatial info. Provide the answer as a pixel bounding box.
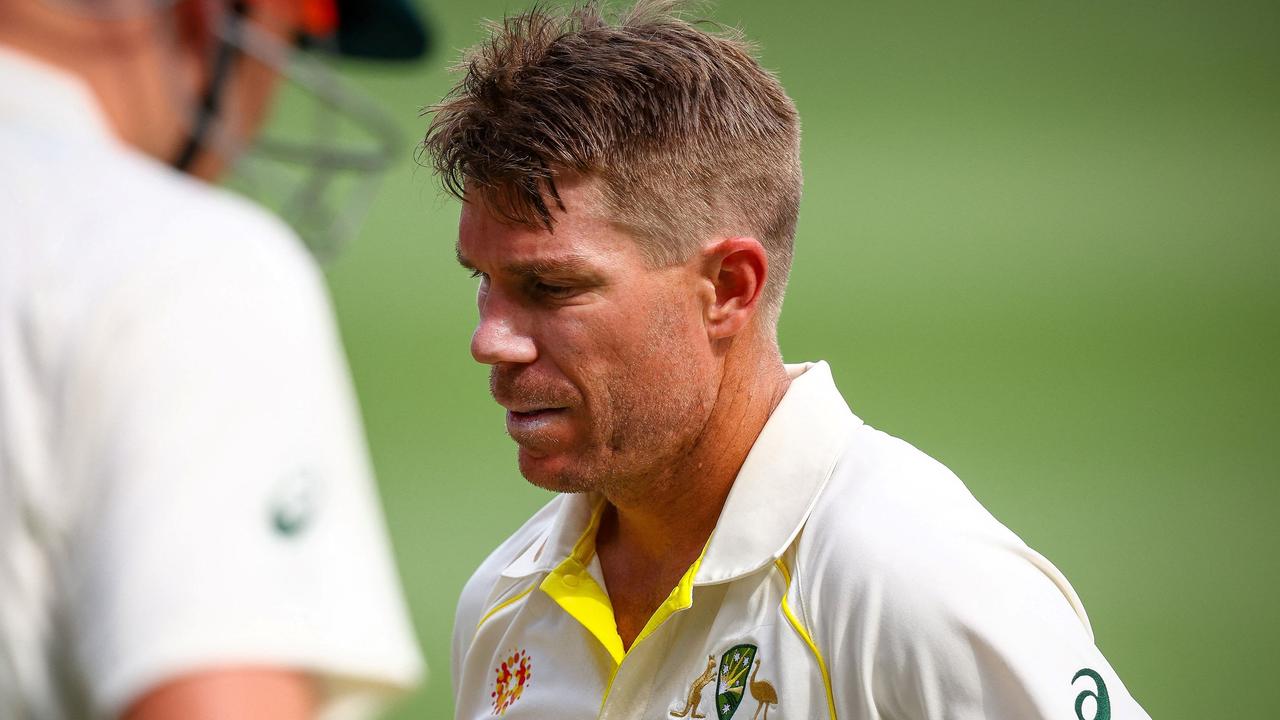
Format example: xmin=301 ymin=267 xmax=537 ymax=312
xmin=0 ymin=0 xmax=424 ymax=720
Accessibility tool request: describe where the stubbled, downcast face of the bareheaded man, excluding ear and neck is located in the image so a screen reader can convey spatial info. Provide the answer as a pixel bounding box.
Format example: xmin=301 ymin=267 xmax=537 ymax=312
xmin=458 ymin=181 xmax=719 ymax=500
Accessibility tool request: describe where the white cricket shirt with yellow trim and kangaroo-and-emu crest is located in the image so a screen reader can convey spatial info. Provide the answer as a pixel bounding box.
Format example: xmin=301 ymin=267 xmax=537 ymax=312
xmin=453 ymin=363 xmax=1147 ymax=720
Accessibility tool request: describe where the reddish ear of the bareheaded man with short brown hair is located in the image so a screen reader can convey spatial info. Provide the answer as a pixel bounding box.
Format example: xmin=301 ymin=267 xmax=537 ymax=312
xmin=703 ymin=237 xmax=769 ymax=340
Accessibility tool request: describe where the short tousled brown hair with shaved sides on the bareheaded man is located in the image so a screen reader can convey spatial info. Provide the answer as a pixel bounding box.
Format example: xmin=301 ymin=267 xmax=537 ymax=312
xmin=422 ymin=0 xmax=801 ymax=318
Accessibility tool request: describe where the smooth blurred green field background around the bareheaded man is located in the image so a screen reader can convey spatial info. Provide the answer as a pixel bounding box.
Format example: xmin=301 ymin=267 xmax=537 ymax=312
xmin=264 ymin=0 xmax=1280 ymax=720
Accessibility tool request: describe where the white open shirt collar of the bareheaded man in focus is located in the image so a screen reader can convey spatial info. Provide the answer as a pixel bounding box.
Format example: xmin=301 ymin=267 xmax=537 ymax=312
xmin=502 ymin=363 xmax=861 ymax=585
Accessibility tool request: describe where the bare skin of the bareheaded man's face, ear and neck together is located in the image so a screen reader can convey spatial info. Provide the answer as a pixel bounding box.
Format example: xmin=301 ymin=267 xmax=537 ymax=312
xmin=458 ymin=178 xmax=788 ymax=647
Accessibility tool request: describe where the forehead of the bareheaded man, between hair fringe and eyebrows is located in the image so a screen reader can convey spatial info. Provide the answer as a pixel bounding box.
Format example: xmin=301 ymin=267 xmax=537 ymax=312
xmin=457 ymin=183 xmax=640 ymax=269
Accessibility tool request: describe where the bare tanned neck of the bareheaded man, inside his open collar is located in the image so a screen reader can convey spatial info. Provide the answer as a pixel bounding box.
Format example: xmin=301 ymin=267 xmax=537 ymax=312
xmin=596 ymin=338 xmax=791 ymax=647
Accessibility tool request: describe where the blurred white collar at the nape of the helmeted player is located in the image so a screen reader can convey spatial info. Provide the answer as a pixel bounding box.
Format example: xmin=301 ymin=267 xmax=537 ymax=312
xmin=0 ymin=45 xmax=115 ymax=140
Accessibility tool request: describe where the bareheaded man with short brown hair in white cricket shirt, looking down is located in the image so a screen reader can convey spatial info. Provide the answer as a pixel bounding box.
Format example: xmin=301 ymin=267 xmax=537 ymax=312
xmin=425 ymin=1 xmax=1146 ymax=720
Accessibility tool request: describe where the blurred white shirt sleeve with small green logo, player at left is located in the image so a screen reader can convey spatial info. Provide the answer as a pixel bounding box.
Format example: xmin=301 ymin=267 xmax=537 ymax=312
xmin=63 ymin=210 xmax=424 ymax=717
